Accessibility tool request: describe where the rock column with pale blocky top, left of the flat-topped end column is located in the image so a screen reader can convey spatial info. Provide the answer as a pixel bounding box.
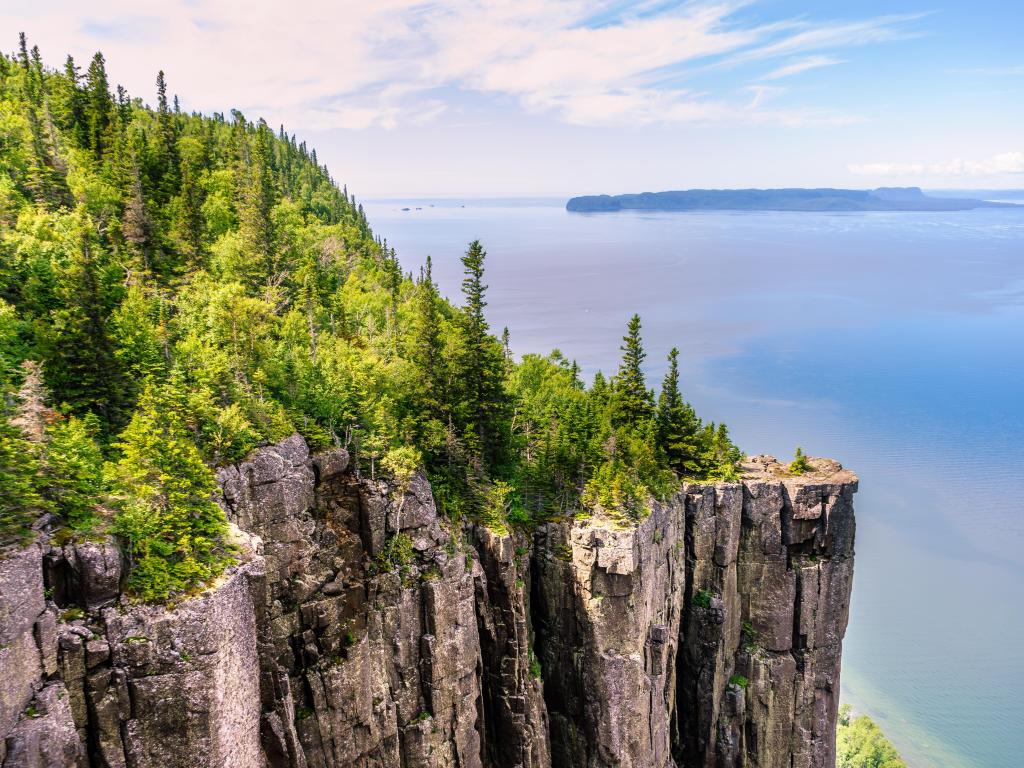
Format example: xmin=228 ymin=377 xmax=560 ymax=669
xmin=535 ymin=499 xmax=685 ymax=768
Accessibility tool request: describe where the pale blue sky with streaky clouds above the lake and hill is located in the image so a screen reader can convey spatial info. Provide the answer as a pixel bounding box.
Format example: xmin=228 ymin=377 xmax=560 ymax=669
xmin=0 ymin=0 xmax=1024 ymax=198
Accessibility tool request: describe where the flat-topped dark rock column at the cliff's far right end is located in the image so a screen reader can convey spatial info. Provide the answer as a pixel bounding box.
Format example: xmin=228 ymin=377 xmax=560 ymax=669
xmin=679 ymin=457 xmax=857 ymax=768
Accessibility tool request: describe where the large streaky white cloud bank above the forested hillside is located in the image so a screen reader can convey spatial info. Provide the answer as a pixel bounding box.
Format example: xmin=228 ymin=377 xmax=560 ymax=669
xmin=0 ymin=0 xmax=920 ymax=129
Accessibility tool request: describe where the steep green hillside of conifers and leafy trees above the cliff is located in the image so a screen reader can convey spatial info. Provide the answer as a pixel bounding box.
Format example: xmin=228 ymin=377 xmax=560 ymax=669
xmin=0 ymin=37 xmax=739 ymax=600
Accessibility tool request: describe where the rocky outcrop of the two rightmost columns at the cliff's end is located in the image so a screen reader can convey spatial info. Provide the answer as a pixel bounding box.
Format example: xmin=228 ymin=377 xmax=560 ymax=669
xmin=535 ymin=457 xmax=857 ymax=768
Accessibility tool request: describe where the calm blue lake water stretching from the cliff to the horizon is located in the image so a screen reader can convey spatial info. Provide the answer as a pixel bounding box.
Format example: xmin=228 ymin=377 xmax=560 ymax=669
xmin=367 ymin=200 xmax=1024 ymax=768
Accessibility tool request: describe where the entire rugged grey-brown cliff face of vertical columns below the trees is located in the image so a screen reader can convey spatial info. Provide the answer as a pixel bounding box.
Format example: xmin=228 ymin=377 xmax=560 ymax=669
xmin=0 ymin=437 xmax=856 ymax=768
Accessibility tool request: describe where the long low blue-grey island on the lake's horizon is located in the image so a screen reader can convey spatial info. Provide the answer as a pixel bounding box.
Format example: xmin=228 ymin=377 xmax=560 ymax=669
xmin=565 ymin=186 xmax=1022 ymax=213
